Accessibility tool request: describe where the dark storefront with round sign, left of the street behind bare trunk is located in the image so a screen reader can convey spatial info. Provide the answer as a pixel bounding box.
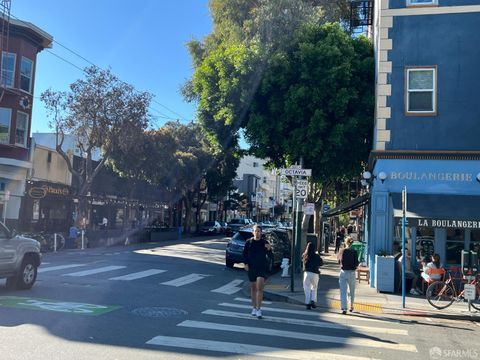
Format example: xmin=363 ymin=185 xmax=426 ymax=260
xmin=21 ymin=181 xmax=74 ymax=232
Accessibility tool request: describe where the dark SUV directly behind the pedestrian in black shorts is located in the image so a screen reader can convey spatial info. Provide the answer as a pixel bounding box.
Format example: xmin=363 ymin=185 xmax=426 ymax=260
xmin=225 ymin=227 xmax=291 ymax=272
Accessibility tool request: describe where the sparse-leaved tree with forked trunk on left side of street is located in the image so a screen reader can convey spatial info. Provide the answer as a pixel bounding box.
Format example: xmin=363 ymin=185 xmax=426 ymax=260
xmin=40 ymin=66 xmax=151 ymax=222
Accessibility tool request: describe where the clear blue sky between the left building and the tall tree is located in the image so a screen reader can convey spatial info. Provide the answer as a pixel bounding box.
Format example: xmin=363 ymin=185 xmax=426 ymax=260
xmin=11 ymin=0 xmax=212 ymax=132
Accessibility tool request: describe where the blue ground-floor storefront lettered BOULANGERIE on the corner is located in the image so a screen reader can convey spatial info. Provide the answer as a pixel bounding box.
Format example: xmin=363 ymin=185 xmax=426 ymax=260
xmin=368 ymin=159 xmax=480 ymax=286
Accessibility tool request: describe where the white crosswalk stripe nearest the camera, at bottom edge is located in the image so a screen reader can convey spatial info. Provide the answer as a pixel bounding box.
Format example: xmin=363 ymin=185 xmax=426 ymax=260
xmin=147 ymin=336 xmax=378 ymax=360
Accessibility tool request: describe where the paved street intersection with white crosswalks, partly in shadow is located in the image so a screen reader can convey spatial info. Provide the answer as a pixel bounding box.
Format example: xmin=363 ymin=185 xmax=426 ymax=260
xmin=0 ymin=238 xmax=480 ymax=359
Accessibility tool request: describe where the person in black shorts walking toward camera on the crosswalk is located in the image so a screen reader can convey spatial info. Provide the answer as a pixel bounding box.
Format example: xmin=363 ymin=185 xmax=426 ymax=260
xmin=243 ymin=225 xmax=272 ymax=319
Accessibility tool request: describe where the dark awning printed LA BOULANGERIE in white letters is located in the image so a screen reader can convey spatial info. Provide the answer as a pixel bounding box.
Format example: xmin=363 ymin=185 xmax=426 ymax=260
xmin=391 ymin=193 xmax=480 ymax=229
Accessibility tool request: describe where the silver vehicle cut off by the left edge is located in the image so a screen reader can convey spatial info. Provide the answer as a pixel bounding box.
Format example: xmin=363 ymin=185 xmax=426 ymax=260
xmin=0 ymin=223 xmax=41 ymax=289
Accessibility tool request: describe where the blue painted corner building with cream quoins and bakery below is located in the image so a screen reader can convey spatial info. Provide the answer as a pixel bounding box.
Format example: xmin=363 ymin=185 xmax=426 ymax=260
xmin=366 ymin=0 xmax=480 ymax=286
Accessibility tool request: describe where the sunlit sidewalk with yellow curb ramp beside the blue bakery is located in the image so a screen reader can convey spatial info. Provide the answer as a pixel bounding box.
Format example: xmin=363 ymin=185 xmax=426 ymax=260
xmin=258 ymin=248 xmax=480 ymax=321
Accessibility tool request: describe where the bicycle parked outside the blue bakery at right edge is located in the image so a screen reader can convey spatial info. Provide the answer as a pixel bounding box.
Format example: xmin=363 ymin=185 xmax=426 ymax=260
xmin=426 ymin=271 xmax=480 ymax=311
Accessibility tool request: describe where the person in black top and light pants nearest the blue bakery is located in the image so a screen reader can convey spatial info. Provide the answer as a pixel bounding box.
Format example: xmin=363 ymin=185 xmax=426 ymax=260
xmin=338 ymin=236 xmax=359 ymax=315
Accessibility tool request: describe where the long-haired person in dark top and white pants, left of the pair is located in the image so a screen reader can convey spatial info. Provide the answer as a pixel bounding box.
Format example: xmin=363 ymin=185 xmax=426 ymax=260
xmin=302 ymin=242 xmax=323 ymax=310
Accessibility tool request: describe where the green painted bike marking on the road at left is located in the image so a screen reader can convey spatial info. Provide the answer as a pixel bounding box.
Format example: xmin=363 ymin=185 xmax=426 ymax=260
xmin=0 ymin=296 xmax=120 ymax=316
